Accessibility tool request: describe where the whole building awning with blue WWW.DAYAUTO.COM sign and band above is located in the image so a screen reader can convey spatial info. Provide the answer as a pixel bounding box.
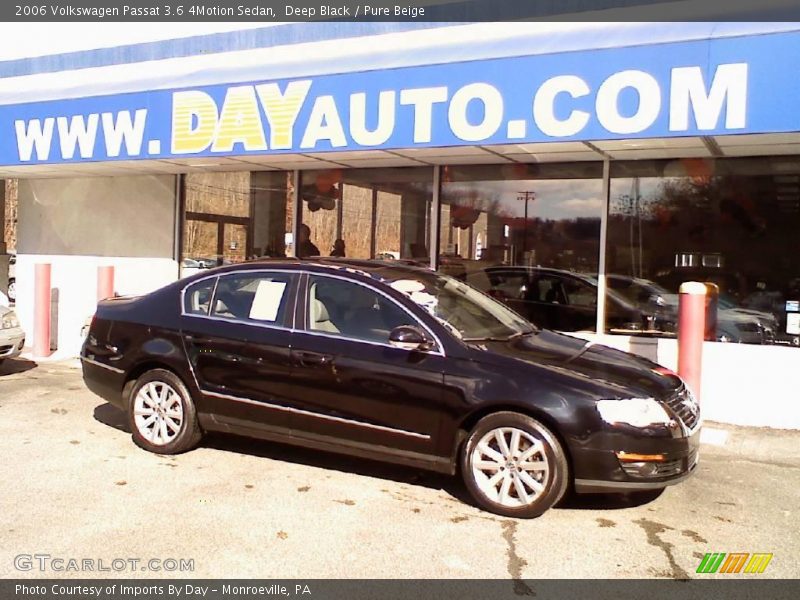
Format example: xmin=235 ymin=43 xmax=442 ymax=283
xmin=0 ymin=23 xmax=800 ymax=171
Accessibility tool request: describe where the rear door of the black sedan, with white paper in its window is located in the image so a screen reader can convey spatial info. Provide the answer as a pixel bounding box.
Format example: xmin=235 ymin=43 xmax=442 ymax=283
xmin=181 ymin=270 xmax=298 ymax=430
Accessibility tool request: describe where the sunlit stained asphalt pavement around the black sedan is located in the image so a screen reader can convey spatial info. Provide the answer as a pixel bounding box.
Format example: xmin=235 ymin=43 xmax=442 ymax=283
xmin=0 ymin=360 xmax=800 ymax=579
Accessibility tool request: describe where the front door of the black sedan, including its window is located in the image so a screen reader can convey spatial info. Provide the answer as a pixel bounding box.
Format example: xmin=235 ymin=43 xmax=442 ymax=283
xmin=292 ymin=274 xmax=446 ymax=455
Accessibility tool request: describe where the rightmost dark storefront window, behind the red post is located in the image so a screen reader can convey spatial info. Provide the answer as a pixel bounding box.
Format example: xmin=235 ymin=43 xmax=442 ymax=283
xmin=605 ymin=156 xmax=800 ymax=345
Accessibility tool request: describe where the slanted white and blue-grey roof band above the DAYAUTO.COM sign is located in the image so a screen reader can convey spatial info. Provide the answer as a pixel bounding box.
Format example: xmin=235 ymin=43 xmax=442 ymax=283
xmin=0 ymin=22 xmax=800 ymax=105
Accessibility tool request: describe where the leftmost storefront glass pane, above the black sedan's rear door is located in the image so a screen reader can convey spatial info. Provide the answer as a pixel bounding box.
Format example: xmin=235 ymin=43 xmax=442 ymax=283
xmin=181 ymin=171 xmax=291 ymax=276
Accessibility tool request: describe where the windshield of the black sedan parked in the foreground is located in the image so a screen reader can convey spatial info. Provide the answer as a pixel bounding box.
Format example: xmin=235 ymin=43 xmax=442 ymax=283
xmin=390 ymin=273 xmax=535 ymax=342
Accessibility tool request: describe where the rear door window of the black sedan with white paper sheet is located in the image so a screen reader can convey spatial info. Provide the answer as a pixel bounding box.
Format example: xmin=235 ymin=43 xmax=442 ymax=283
xmin=211 ymin=273 xmax=291 ymax=324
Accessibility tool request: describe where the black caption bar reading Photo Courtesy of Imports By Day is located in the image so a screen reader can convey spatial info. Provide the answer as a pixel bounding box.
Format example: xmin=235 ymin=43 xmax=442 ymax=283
xmin=0 ymin=576 xmax=800 ymax=600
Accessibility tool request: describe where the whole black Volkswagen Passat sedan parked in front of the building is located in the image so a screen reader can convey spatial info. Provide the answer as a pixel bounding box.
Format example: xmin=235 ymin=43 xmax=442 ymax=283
xmin=82 ymin=259 xmax=700 ymax=517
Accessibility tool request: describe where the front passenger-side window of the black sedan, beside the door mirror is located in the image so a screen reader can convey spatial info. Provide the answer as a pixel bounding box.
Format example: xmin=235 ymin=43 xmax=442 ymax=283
xmin=308 ymin=275 xmax=417 ymax=343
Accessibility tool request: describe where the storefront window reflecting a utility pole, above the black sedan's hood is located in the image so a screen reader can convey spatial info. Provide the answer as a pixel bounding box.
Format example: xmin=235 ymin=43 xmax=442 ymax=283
xmin=439 ymin=162 xmax=603 ymax=331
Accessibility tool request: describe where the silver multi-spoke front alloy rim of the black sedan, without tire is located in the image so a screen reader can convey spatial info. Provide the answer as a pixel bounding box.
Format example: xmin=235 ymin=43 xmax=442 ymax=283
xmin=470 ymin=427 xmax=551 ymax=508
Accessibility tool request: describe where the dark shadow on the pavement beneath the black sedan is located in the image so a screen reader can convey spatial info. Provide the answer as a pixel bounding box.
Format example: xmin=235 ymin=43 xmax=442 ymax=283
xmin=94 ymin=403 xmax=663 ymax=510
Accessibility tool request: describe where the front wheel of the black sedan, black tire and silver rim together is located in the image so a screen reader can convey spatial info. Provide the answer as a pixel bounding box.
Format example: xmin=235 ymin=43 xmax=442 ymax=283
xmin=460 ymin=412 xmax=570 ymax=519
